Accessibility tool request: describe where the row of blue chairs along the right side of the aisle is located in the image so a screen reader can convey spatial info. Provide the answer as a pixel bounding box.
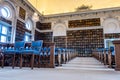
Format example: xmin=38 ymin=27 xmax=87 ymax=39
xmin=93 ymin=46 xmax=115 ymax=68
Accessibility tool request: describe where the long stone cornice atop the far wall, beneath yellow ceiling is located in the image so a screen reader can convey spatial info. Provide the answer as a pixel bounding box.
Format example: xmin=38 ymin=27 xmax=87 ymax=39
xmin=42 ymin=7 xmax=120 ymax=22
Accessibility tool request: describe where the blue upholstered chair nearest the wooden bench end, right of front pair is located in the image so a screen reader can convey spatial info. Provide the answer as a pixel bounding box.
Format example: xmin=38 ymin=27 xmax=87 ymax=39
xmin=20 ymin=40 xmax=43 ymax=69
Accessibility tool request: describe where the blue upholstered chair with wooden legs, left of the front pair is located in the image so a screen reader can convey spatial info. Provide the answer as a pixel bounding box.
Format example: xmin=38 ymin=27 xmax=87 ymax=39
xmin=2 ymin=41 xmax=25 ymax=68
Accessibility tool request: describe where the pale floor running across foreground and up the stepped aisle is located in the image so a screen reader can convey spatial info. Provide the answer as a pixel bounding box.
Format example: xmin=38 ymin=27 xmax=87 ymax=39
xmin=0 ymin=57 xmax=120 ymax=80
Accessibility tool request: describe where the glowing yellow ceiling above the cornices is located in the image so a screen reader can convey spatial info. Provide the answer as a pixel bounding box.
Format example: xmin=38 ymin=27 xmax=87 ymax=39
xmin=28 ymin=0 xmax=120 ymax=15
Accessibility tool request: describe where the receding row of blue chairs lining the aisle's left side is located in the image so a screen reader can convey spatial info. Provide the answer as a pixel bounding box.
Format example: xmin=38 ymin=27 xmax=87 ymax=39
xmin=55 ymin=48 xmax=77 ymax=66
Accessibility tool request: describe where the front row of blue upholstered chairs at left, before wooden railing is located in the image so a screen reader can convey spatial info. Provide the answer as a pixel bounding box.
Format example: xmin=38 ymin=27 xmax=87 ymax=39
xmin=1 ymin=40 xmax=45 ymax=69
